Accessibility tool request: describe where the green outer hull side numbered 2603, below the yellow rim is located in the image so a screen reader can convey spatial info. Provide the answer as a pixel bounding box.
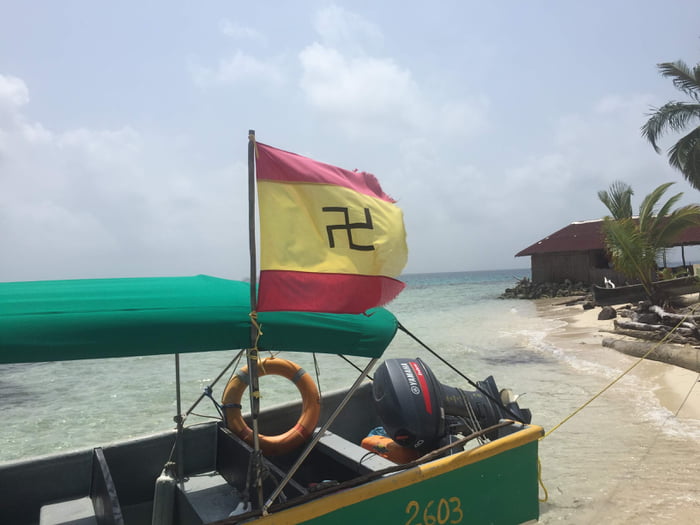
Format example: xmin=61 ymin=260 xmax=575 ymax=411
xmin=256 ymin=426 xmax=542 ymax=525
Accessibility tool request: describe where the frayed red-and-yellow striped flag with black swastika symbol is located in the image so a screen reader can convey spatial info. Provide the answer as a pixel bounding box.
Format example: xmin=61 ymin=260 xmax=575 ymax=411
xmin=256 ymin=142 xmax=408 ymax=313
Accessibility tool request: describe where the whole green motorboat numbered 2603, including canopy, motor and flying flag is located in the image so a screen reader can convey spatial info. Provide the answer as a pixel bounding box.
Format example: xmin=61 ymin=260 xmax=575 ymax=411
xmin=0 ymin=136 xmax=543 ymax=525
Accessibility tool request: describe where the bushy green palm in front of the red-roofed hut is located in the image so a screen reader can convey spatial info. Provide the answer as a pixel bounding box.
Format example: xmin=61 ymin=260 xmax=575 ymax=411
xmin=598 ymin=182 xmax=700 ymax=302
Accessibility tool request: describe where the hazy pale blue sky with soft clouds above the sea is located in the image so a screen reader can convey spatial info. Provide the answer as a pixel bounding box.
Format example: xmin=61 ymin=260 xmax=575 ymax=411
xmin=0 ymin=0 xmax=700 ymax=281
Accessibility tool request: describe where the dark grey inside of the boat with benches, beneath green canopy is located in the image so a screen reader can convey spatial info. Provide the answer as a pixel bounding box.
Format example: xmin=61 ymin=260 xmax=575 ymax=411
xmin=0 ymin=386 xmax=395 ymax=525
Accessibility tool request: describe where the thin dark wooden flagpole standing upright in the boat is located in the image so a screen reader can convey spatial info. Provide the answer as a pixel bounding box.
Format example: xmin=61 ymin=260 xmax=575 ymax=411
xmin=246 ymin=129 xmax=263 ymax=505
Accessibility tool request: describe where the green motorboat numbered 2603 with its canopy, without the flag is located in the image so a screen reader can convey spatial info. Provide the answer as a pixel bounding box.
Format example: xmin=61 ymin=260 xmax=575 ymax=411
xmin=0 ymin=275 xmax=543 ymax=525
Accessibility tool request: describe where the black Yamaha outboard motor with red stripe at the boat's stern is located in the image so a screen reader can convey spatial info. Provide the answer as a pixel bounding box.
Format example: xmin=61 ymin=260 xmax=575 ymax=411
xmin=372 ymin=358 xmax=532 ymax=449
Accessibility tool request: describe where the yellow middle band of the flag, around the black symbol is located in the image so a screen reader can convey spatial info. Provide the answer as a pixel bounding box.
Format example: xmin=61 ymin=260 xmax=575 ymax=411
xmin=258 ymin=181 xmax=408 ymax=277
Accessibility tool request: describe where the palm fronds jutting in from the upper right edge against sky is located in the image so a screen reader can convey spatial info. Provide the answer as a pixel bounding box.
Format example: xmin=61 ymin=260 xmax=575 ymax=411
xmin=642 ymin=60 xmax=700 ymax=190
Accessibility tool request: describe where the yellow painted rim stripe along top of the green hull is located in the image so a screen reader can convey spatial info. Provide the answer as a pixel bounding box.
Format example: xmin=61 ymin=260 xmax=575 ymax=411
xmin=255 ymin=425 xmax=544 ymax=525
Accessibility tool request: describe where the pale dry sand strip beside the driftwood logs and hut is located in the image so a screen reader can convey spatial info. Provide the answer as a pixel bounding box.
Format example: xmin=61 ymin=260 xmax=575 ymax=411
xmin=535 ymin=297 xmax=700 ymax=420
